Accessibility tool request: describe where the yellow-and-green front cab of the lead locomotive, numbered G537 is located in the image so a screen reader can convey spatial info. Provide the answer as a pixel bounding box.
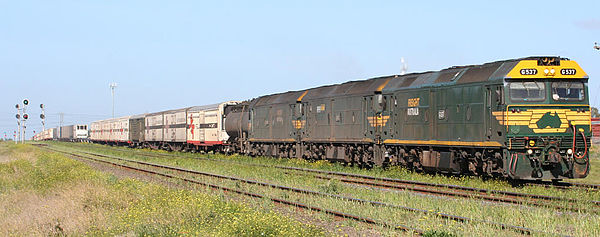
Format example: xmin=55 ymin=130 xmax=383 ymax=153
xmin=493 ymin=57 xmax=591 ymax=179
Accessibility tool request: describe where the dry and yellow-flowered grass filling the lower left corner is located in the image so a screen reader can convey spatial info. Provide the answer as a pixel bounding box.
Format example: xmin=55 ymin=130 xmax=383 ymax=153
xmin=0 ymin=142 xmax=326 ymax=236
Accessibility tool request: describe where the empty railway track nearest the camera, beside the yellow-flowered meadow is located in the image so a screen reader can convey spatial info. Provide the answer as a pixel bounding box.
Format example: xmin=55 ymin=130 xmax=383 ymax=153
xmin=35 ymin=144 xmax=548 ymax=235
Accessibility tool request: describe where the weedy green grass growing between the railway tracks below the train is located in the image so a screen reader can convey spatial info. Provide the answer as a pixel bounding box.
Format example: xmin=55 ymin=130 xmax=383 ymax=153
xmin=45 ymin=143 xmax=600 ymax=236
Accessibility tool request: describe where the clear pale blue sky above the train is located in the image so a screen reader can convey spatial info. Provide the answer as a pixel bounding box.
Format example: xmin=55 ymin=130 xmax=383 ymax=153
xmin=0 ymin=0 xmax=600 ymax=137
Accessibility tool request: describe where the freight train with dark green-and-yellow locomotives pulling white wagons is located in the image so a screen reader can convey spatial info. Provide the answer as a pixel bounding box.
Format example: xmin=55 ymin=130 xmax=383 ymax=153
xmin=34 ymin=57 xmax=591 ymax=179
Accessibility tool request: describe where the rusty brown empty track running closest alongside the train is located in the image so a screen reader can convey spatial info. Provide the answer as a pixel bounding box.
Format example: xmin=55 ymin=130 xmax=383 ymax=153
xmin=75 ymin=143 xmax=600 ymax=214
